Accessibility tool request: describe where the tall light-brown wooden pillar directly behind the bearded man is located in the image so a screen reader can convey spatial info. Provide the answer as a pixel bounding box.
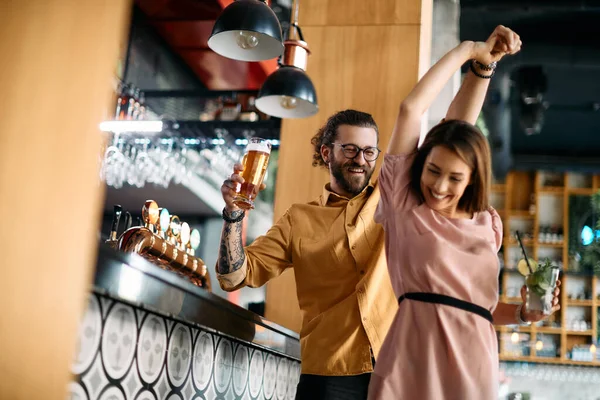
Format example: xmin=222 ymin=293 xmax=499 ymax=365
xmin=265 ymin=0 xmax=432 ymax=332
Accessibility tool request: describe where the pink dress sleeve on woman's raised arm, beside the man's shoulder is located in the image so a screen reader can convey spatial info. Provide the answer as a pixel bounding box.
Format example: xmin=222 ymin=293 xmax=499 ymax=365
xmin=375 ymin=151 xmax=419 ymax=224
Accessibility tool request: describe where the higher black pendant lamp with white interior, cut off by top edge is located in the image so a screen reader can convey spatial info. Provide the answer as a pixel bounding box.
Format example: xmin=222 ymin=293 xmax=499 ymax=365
xmin=208 ymin=0 xmax=283 ymax=61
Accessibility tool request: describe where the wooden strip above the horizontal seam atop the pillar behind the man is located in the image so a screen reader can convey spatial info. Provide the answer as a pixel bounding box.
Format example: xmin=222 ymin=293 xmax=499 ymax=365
xmin=298 ymin=0 xmax=427 ymax=27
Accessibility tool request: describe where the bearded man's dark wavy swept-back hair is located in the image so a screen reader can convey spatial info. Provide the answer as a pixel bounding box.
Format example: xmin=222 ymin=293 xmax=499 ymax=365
xmin=310 ymin=110 xmax=379 ymax=167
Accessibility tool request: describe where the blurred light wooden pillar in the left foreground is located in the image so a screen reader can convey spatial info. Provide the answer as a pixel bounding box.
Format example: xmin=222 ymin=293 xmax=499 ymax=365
xmin=0 ymin=0 xmax=131 ymax=400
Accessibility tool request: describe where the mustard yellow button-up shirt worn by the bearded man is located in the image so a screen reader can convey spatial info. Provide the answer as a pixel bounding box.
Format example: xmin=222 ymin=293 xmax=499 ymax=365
xmin=218 ymin=184 xmax=398 ymax=375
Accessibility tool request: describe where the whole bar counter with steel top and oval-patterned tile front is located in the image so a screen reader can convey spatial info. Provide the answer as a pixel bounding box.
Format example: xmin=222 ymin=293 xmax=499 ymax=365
xmin=69 ymin=245 xmax=300 ymax=400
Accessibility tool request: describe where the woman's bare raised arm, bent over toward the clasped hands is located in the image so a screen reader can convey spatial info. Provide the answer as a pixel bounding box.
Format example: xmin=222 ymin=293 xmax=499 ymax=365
xmin=387 ymin=27 xmax=520 ymax=154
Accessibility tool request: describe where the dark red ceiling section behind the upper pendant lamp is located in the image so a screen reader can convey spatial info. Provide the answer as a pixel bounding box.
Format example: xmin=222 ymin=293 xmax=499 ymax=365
xmin=136 ymin=0 xmax=277 ymax=90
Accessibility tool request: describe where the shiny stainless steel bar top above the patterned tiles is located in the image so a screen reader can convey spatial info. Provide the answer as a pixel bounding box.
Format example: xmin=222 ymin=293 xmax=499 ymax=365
xmin=93 ymin=244 xmax=300 ymax=361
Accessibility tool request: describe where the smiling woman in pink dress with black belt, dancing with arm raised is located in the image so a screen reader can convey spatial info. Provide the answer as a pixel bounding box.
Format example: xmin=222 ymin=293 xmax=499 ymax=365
xmin=369 ymin=26 xmax=544 ymax=400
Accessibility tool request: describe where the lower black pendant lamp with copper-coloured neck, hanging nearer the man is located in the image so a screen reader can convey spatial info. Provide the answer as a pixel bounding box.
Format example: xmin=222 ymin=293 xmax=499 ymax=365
xmin=256 ymin=1 xmax=319 ymax=118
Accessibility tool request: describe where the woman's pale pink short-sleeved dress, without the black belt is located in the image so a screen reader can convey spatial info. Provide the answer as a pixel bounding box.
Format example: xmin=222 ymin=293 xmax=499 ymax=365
xmin=369 ymin=153 xmax=502 ymax=400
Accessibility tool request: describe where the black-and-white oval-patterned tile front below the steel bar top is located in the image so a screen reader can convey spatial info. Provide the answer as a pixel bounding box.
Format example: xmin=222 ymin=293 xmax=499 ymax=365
xmin=67 ymin=294 xmax=300 ymax=400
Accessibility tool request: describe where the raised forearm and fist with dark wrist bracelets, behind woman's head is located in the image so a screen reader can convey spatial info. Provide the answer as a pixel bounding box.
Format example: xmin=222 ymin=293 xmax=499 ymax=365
xmin=446 ymin=25 xmax=521 ymax=124
